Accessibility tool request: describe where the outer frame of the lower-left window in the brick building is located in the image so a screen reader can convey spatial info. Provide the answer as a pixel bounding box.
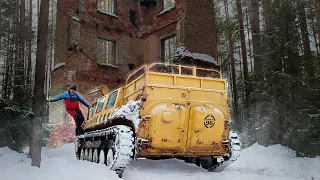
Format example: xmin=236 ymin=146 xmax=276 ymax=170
xmin=96 ymin=36 xmax=118 ymax=67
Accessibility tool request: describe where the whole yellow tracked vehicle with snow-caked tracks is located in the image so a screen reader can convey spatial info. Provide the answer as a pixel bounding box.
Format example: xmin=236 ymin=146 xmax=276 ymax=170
xmin=76 ymin=63 xmax=240 ymax=176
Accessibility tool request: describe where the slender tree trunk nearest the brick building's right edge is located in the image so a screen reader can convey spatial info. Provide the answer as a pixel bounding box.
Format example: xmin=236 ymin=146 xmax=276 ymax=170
xmin=224 ymin=0 xmax=239 ymax=118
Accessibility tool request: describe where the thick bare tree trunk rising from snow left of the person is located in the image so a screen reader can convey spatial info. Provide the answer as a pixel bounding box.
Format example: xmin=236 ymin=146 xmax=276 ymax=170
xmin=31 ymin=0 xmax=50 ymax=167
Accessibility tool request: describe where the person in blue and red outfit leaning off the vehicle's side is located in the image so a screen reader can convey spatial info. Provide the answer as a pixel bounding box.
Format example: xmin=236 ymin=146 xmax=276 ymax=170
xmin=48 ymin=85 xmax=89 ymax=135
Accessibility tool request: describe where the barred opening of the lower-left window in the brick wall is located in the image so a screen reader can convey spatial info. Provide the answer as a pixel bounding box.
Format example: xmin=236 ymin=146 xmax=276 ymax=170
xmin=97 ymin=38 xmax=116 ymax=66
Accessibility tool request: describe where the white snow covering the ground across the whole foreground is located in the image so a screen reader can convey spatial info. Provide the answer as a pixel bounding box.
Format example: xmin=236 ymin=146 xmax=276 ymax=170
xmin=0 ymin=144 xmax=320 ymax=180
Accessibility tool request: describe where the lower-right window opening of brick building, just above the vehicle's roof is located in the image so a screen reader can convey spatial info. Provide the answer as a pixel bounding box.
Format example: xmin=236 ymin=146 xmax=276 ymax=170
xmin=161 ymin=35 xmax=177 ymax=63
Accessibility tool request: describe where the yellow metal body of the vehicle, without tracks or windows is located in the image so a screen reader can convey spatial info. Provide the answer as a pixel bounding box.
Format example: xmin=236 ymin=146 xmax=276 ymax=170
xmin=85 ymin=64 xmax=230 ymax=157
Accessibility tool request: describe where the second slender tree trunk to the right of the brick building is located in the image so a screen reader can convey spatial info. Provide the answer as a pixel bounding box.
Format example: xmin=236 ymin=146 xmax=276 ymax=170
xmin=236 ymin=0 xmax=251 ymax=115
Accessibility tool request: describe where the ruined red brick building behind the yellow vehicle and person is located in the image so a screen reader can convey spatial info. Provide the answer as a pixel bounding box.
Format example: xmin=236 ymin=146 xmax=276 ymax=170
xmin=50 ymin=0 xmax=217 ymax=146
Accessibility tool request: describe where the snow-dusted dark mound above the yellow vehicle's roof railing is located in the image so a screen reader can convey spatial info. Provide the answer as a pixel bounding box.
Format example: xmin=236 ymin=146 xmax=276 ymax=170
xmin=174 ymin=46 xmax=219 ymax=66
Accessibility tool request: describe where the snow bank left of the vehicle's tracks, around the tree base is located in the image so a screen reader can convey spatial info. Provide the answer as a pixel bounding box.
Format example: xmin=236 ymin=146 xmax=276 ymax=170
xmin=0 ymin=144 xmax=119 ymax=180
